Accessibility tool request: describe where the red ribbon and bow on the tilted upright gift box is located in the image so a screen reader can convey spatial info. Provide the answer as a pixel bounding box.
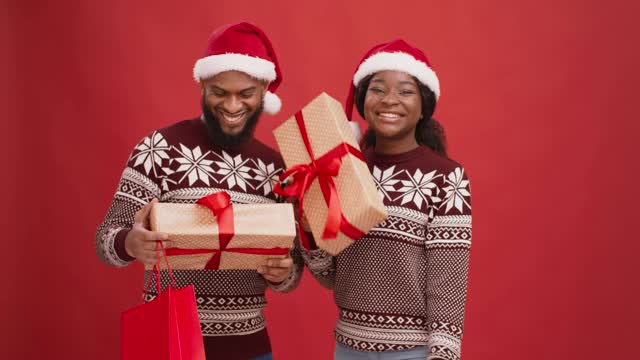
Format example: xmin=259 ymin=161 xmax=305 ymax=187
xmin=273 ymin=111 xmax=365 ymax=249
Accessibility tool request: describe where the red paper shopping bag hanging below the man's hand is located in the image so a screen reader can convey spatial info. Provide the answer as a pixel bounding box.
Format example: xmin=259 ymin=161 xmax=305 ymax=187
xmin=120 ymin=242 xmax=205 ymax=360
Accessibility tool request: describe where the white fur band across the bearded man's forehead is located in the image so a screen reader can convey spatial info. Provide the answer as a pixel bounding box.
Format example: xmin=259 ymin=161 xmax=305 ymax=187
xmin=193 ymin=54 xmax=276 ymax=82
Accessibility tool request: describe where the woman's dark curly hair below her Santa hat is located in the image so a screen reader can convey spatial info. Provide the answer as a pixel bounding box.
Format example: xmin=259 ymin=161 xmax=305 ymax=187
xmin=355 ymin=75 xmax=447 ymax=157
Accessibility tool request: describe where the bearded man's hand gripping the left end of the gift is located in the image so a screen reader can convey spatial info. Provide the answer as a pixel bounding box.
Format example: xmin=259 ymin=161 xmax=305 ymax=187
xmin=124 ymin=199 xmax=171 ymax=265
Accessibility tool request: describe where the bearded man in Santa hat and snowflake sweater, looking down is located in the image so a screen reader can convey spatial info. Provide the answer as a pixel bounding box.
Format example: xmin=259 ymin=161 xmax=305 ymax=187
xmin=96 ymin=23 xmax=302 ymax=360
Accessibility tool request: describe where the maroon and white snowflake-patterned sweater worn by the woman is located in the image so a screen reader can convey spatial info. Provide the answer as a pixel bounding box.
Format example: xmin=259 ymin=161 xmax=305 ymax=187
xmin=302 ymin=146 xmax=471 ymax=360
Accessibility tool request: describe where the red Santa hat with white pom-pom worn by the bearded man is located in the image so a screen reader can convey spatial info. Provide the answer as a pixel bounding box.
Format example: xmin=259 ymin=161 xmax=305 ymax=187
xmin=193 ymin=22 xmax=282 ymax=114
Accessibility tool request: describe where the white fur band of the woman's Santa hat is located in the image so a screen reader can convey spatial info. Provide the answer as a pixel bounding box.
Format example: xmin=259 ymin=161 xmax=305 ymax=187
xmin=353 ymin=52 xmax=440 ymax=99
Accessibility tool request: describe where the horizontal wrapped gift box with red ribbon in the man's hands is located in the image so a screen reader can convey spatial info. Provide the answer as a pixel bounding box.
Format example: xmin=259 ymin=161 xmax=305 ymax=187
xmin=148 ymin=192 xmax=296 ymax=270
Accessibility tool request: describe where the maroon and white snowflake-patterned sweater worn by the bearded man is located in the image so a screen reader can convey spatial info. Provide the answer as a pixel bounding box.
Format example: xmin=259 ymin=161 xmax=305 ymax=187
xmin=96 ymin=118 xmax=304 ymax=359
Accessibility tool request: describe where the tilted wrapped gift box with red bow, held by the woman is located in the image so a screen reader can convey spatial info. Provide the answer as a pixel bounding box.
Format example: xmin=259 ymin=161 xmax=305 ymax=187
xmin=273 ymin=93 xmax=387 ymax=255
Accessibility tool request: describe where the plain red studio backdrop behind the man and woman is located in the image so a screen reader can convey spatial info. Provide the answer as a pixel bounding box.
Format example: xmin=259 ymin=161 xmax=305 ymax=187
xmin=0 ymin=0 xmax=640 ymax=360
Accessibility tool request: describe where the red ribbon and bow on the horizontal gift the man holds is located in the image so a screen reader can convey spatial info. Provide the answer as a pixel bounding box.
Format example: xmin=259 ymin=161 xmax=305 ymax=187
xmin=166 ymin=191 xmax=289 ymax=270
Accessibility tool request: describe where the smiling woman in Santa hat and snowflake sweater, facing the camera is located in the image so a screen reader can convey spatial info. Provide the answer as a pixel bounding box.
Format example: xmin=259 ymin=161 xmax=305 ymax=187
xmin=304 ymin=40 xmax=471 ymax=360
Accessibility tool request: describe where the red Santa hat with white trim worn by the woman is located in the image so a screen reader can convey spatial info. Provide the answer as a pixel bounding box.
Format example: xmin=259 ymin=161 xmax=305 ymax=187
xmin=345 ymin=39 xmax=440 ymax=124
